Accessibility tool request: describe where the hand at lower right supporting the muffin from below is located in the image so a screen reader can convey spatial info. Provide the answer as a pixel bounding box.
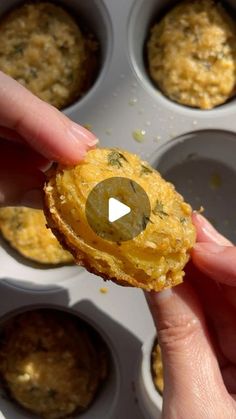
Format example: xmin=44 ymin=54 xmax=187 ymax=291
xmin=148 ymin=214 xmax=236 ymax=419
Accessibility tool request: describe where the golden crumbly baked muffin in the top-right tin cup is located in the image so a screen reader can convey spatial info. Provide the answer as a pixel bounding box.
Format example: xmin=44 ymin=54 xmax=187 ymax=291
xmin=147 ymin=0 xmax=236 ymax=109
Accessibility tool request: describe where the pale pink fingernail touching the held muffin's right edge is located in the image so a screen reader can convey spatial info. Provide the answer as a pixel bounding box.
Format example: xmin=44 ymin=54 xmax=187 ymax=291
xmin=192 ymin=213 xmax=232 ymax=246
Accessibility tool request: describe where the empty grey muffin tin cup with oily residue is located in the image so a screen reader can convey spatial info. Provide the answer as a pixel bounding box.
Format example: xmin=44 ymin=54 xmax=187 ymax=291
xmin=153 ymin=130 xmax=236 ymax=242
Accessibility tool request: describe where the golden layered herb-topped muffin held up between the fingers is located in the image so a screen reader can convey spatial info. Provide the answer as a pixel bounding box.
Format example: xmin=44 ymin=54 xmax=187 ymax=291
xmin=45 ymin=148 xmax=196 ymax=291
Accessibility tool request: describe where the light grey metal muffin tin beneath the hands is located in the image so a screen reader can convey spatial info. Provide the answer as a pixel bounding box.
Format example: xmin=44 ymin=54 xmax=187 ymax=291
xmin=0 ymin=0 xmax=236 ymax=419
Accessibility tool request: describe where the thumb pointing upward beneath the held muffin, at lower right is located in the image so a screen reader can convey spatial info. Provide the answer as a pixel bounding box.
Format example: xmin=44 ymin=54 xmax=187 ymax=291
xmin=147 ymin=282 xmax=225 ymax=419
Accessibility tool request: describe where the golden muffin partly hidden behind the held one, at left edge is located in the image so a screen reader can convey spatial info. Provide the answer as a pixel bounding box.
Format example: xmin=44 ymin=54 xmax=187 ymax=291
xmin=0 ymin=207 xmax=74 ymax=265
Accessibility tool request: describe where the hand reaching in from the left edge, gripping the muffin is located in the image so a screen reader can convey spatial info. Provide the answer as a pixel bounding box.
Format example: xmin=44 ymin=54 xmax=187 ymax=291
xmin=0 ymin=72 xmax=97 ymax=207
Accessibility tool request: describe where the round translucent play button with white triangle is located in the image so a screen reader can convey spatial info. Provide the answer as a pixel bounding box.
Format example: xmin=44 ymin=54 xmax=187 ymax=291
xmin=85 ymin=177 xmax=151 ymax=244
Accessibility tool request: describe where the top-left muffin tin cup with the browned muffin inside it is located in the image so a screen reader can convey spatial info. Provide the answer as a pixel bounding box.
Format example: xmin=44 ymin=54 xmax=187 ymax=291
xmin=0 ymin=0 xmax=112 ymax=109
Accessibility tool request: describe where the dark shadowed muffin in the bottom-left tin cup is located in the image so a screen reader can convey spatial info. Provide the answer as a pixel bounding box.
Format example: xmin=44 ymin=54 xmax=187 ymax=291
xmin=0 ymin=309 xmax=109 ymax=419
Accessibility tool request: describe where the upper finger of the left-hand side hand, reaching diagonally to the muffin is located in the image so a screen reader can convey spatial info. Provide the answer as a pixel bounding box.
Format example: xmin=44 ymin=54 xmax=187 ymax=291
xmin=0 ymin=72 xmax=97 ymax=164
